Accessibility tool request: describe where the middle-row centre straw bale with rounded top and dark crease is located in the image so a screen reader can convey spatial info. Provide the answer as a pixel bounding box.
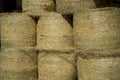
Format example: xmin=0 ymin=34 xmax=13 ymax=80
xmin=37 ymin=12 xmax=73 ymax=51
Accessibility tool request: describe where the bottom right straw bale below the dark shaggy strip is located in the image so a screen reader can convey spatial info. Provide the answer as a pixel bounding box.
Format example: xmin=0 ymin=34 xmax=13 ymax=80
xmin=77 ymin=56 xmax=120 ymax=80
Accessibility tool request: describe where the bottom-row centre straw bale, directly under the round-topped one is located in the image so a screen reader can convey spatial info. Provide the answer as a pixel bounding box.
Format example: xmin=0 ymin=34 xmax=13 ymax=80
xmin=38 ymin=51 xmax=76 ymax=80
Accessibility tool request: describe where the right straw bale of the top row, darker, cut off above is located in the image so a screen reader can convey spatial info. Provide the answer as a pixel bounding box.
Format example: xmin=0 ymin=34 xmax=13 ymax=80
xmin=56 ymin=0 xmax=96 ymax=14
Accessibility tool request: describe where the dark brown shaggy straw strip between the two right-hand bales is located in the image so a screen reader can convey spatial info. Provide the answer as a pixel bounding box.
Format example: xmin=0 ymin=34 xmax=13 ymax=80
xmin=75 ymin=50 xmax=120 ymax=59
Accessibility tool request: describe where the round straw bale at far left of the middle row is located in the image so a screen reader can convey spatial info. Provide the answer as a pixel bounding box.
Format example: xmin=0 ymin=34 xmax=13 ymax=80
xmin=0 ymin=13 xmax=36 ymax=47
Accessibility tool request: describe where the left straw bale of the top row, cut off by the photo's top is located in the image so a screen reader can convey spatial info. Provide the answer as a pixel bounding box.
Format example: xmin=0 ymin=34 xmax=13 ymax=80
xmin=22 ymin=0 xmax=55 ymax=16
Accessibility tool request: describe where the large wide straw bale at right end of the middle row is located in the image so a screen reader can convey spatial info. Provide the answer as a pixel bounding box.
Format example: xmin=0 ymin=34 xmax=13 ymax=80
xmin=74 ymin=7 xmax=120 ymax=51
